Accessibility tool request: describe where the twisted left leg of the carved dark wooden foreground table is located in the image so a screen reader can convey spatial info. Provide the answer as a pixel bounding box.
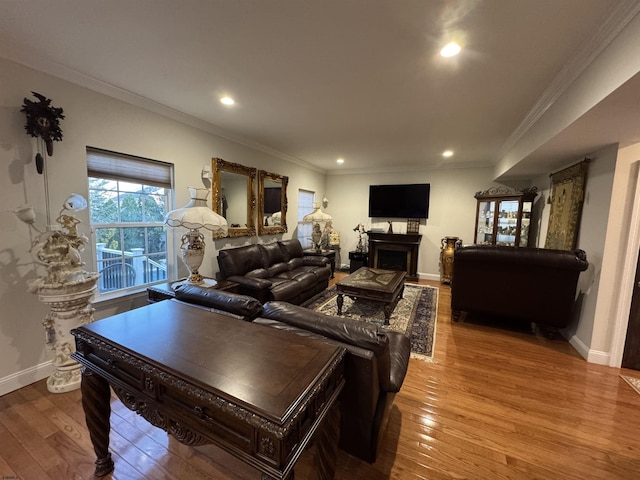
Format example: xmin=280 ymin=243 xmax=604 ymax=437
xmin=80 ymin=368 xmax=114 ymax=477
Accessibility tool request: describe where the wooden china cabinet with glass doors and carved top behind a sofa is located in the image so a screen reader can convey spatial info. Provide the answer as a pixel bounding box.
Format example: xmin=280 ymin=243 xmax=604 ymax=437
xmin=474 ymin=187 xmax=538 ymax=247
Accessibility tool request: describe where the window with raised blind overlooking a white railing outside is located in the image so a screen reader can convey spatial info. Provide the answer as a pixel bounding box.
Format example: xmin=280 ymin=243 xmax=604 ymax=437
xmin=87 ymin=149 xmax=173 ymax=294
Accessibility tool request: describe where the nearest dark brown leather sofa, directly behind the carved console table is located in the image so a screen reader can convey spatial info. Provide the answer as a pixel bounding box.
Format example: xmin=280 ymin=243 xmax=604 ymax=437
xmin=171 ymin=286 xmax=411 ymax=463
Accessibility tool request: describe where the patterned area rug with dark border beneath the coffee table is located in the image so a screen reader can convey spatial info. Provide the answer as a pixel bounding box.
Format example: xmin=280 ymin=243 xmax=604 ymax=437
xmin=304 ymin=284 xmax=438 ymax=362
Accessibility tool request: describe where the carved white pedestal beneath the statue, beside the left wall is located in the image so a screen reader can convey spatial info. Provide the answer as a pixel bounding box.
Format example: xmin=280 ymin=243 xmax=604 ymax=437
xmin=37 ymin=274 xmax=99 ymax=393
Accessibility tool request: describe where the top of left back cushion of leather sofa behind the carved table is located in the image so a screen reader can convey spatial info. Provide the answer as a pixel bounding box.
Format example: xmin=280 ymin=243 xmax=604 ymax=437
xmin=176 ymin=285 xmax=262 ymax=320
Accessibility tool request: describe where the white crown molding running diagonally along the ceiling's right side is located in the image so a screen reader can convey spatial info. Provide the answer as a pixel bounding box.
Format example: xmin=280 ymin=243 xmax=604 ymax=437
xmin=498 ymin=0 xmax=640 ymax=158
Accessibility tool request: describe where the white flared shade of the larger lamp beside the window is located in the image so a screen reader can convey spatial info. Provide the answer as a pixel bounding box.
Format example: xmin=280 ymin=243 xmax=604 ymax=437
xmin=164 ymin=187 xmax=228 ymax=236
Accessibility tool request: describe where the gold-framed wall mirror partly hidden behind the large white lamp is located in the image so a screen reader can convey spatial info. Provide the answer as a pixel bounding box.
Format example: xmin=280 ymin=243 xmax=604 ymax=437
xmin=211 ymin=158 xmax=257 ymax=237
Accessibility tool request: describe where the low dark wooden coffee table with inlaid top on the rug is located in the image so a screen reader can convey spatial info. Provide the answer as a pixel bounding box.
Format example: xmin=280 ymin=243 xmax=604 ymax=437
xmin=336 ymin=267 xmax=407 ymax=325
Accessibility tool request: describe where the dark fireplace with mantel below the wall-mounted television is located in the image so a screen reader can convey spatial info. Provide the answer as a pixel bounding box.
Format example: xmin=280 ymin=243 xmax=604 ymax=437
xmin=367 ymin=232 xmax=422 ymax=281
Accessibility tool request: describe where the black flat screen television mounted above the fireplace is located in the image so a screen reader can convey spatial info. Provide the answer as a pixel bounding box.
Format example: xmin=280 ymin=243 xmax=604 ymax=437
xmin=369 ymin=183 xmax=431 ymax=218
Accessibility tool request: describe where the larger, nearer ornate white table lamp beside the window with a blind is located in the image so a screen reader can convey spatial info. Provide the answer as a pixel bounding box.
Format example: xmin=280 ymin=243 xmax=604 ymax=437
xmin=164 ymin=187 xmax=228 ymax=287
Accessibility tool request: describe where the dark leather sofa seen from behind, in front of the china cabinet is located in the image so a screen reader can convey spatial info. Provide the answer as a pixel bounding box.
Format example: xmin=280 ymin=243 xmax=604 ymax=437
xmin=451 ymin=245 xmax=589 ymax=330
